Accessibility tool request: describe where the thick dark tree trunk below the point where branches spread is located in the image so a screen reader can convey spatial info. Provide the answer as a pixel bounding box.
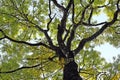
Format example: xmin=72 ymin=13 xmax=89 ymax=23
xmin=63 ymin=60 xmax=83 ymax=80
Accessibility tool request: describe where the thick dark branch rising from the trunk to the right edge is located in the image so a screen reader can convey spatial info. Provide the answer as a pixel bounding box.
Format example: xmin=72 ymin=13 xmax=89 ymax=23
xmin=73 ymin=9 xmax=120 ymax=55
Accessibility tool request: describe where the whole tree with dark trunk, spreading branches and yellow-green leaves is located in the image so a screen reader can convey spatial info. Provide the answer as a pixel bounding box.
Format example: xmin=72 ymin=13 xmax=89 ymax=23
xmin=0 ymin=0 xmax=120 ymax=80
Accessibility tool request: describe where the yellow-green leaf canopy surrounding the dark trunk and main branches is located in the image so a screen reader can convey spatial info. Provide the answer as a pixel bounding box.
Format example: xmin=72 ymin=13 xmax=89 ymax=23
xmin=0 ymin=0 xmax=120 ymax=80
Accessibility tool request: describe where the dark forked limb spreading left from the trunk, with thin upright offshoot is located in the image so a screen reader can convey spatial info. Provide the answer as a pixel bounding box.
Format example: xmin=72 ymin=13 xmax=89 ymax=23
xmin=1 ymin=0 xmax=56 ymax=50
